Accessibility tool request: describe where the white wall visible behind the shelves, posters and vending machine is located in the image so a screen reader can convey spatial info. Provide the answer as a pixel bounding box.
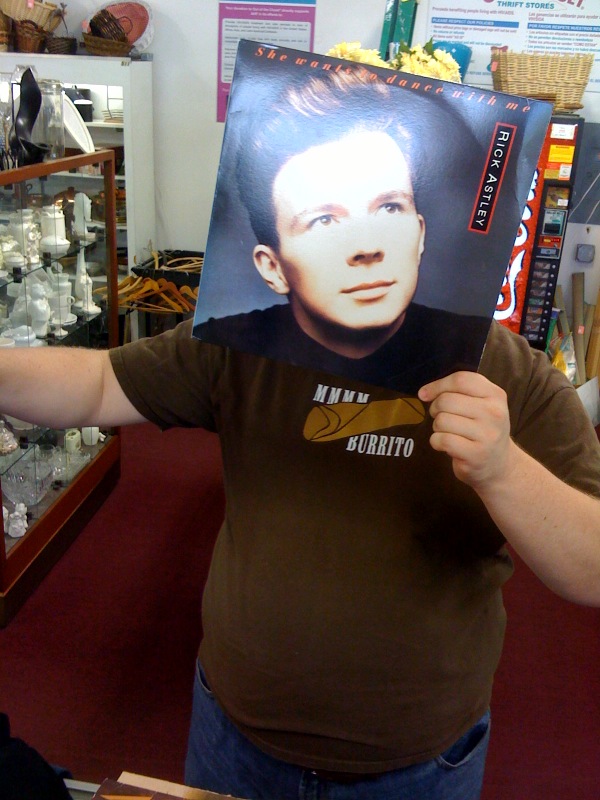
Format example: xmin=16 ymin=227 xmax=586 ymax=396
xmin=56 ymin=0 xmax=600 ymax=316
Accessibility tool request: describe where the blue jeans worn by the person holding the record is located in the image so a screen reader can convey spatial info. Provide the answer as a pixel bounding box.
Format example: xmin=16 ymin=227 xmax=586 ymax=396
xmin=185 ymin=669 xmax=490 ymax=800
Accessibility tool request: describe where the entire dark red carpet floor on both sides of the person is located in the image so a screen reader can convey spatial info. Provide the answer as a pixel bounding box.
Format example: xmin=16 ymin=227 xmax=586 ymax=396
xmin=0 ymin=425 xmax=600 ymax=800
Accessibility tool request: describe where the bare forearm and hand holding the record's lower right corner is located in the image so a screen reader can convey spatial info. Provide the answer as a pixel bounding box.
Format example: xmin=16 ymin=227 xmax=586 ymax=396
xmin=419 ymin=372 xmax=600 ymax=606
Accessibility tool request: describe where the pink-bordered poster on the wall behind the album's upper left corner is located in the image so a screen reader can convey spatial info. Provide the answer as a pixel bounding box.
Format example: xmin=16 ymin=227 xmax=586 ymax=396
xmin=217 ymin=0 xmax=317 ymax=122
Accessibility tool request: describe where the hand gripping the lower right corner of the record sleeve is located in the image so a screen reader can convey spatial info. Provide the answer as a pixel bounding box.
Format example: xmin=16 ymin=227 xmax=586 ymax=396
xmin=419 ymin=372 xmax=514 ymax=490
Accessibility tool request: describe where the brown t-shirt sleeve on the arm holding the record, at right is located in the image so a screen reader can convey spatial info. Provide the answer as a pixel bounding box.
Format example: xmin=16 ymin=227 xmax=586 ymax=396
xmin=480 ymin=324 xmax=600 ymax=497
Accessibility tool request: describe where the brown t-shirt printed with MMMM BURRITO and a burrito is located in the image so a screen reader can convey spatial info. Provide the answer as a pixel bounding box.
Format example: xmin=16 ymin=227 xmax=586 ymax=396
xmin=111 ymin=323 xmax=600 ymax=772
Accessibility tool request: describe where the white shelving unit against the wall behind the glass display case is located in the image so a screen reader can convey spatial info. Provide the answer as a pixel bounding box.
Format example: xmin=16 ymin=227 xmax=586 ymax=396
xmin=0 ymin=53 xmax=156 ymax=271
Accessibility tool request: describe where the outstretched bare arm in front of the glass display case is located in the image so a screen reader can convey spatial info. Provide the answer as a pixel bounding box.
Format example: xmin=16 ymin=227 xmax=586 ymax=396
xmin=0 ymin=347 xmax=144 ymax=428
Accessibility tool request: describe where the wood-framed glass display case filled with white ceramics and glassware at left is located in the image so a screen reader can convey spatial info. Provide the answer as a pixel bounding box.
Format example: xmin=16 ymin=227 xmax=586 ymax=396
xmin=0 ymin=150 xmax=120 ymax=626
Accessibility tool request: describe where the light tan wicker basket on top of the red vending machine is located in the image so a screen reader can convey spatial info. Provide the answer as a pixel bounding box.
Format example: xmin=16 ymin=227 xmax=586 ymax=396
xmin=491 ymin=47 xmax=594 ymax=112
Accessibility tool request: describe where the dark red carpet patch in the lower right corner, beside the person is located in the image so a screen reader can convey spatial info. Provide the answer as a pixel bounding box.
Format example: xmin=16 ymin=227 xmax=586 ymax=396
xmin=482 ymin=561 xmax=600 ymax=800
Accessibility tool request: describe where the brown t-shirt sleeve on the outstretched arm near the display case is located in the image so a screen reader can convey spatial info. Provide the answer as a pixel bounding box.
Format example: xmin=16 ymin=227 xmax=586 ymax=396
xmin=110 ymin=320 xmax=223 ymax=431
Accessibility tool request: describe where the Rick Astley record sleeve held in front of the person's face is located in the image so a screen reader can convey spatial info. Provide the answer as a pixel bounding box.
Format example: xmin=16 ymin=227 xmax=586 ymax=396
xmin=194 ymin=40 xmax=552 ymax=394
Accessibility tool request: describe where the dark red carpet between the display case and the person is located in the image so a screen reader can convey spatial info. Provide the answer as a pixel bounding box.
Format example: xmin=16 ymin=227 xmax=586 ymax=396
xmin=0 ymin=425 xmax=223 ymax=782
